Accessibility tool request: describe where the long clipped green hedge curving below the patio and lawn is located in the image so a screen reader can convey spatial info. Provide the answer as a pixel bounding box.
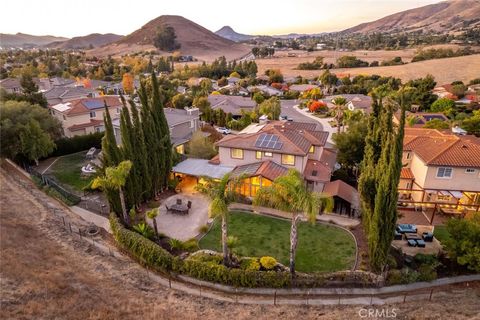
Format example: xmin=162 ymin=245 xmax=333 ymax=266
xmin=110 ymin=214 xmax=291 ymax=288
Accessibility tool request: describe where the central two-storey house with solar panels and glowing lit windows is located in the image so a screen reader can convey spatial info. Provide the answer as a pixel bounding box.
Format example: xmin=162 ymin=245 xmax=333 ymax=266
xmin=173 ymin=121 xmax=358 ymax=213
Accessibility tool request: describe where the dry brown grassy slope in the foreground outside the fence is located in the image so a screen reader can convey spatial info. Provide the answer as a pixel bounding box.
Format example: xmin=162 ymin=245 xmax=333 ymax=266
xmin=0 ymin=169 xmax=480 ymax=319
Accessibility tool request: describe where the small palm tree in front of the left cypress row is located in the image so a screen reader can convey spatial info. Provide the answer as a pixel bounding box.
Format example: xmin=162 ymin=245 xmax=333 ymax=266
xmin=92 ymin=160 xmax=132 ymax=225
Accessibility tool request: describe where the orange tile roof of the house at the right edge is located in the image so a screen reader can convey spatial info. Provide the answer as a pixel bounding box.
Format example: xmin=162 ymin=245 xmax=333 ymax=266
xmin=403 ymin=128 xmax=480 ymax=168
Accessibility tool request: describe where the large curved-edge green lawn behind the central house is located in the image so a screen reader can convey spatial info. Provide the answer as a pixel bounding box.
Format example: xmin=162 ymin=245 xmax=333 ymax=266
xmin=200 ymin=212 xmax=355 ymax=272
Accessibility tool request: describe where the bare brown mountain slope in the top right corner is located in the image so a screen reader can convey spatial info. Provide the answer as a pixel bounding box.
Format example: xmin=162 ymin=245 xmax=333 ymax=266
xmin=343 ymin=0 xmax=480 ymax=33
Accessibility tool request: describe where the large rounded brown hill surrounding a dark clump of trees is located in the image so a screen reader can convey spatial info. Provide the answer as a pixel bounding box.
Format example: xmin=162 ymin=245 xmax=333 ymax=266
xmin=94 ymin=15 xmax=250 ymax=61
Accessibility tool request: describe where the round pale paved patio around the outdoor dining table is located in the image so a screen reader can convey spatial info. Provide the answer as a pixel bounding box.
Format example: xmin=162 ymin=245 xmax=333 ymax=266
xmin=151 ymin=193 xmax=210 ymax=241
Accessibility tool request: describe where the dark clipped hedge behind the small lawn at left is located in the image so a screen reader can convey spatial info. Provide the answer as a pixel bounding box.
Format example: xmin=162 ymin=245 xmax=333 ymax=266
xmin=49 ymin=132 xmax=104 ymax=157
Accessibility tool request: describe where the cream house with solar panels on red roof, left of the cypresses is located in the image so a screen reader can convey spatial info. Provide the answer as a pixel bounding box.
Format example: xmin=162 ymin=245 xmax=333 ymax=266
xmin=49 ymin=96 xmax=123 ymax=137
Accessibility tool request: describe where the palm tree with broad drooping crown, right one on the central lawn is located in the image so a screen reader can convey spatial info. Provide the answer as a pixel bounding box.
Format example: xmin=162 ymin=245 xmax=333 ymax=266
xmin=253 ymin=169 xmax=333 ymax=277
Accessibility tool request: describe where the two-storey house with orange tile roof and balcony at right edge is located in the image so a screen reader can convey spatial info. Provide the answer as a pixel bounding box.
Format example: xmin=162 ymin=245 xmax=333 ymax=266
xmin=398 ymin=128 xmax=480 ymax=224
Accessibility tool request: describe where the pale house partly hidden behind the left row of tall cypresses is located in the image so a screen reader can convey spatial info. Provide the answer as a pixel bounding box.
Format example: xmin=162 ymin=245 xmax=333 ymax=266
xmin=112 ymin=108 xmax=200 ymax=154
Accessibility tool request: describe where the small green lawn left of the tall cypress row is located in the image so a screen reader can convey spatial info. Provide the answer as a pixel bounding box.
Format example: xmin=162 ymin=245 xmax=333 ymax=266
xmin=48 ymin=151 xmax=94 ymax=191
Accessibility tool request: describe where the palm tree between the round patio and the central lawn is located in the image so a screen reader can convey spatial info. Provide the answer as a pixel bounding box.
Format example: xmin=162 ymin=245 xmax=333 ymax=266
xmin=197 ymin=173 xmax=243 ymax=265
